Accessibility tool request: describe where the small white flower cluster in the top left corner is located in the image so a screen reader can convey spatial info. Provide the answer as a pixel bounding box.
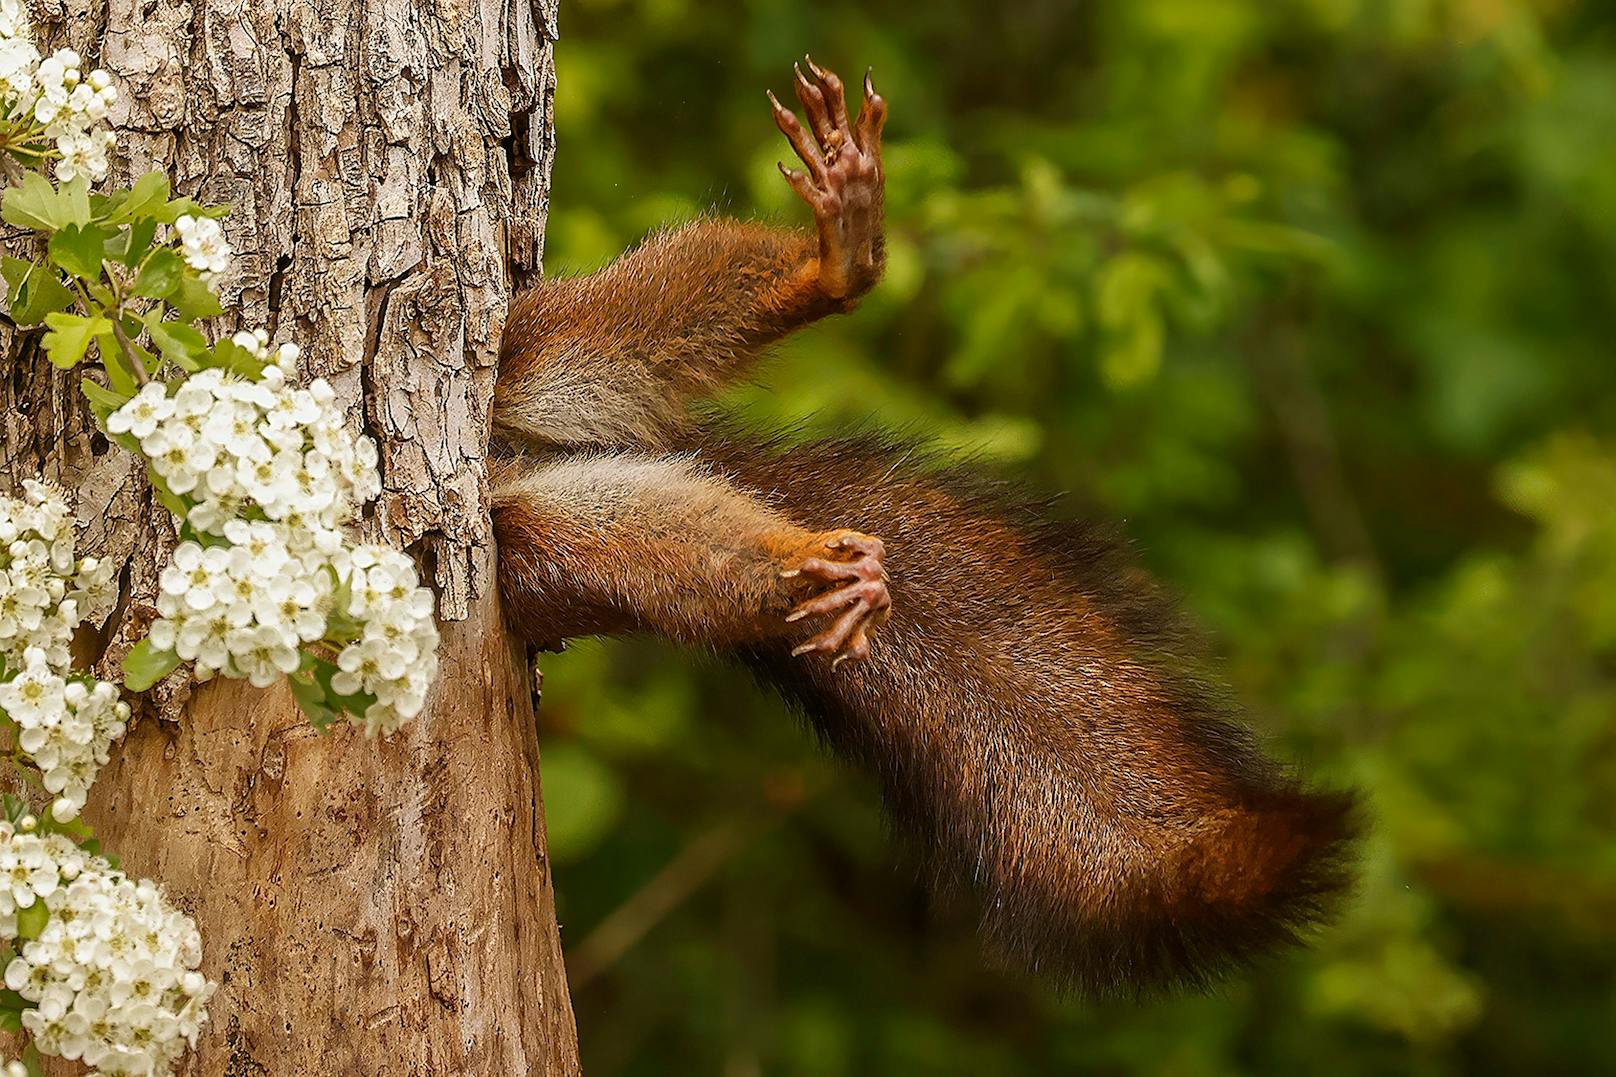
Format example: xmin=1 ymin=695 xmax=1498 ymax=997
xmin=0 ymin=0 xmax=118 ymax=183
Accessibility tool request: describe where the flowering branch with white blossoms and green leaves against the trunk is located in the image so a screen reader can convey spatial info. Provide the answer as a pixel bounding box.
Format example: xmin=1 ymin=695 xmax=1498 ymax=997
xmin=0 ymin=0 xmax=438 ymax=1077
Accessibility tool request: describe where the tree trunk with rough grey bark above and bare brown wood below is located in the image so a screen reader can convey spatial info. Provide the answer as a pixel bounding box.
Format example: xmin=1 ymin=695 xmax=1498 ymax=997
xmin=0 ymin=0 xmax=579 ymax=1077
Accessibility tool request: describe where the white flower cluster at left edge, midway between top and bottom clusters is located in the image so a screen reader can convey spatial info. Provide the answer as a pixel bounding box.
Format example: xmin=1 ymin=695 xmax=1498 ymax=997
xmin=0 ymin=482 xmax=129 ymax=821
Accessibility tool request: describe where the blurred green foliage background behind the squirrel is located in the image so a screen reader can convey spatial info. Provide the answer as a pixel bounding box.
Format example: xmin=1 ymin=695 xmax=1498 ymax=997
xmin=540 ymin=0 xmax=1616 ymax=1077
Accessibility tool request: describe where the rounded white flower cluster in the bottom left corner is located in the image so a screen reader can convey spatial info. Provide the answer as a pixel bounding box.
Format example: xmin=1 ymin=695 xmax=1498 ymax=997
xmin=0 ymin=818 xmax=215 ymax=1077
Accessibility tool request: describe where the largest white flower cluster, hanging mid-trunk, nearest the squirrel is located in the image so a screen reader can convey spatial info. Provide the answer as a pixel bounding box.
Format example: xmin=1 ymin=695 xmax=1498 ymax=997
xmin=107 ymin=341 xmax=438 ymax=734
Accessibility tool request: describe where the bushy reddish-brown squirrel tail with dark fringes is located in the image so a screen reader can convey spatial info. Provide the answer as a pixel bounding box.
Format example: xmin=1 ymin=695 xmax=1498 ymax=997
xmin=703 ymin=426 xmax=1357 ymax=995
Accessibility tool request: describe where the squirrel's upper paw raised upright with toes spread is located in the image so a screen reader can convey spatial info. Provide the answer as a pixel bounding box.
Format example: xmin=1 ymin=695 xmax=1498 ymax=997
xmin=769 ymin=57 xmax=887 ymax=304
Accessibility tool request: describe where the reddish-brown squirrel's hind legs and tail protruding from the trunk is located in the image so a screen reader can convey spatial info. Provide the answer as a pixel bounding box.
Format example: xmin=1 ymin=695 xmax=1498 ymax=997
xmin=490 ymin=58 xmax=1357 ymax=995
